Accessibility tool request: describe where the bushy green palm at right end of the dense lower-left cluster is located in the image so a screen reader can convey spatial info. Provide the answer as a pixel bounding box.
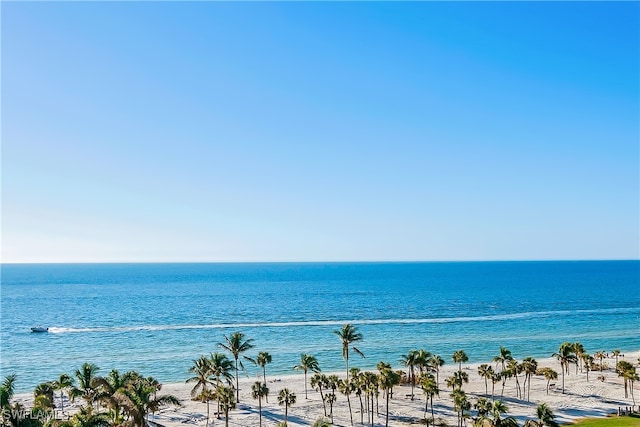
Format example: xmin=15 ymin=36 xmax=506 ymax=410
xmin=116 ymin=380 xmax=182 ymax=427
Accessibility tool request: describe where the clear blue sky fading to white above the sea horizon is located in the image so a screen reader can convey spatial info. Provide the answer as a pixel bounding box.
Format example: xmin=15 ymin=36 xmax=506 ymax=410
xmin=1 ymin=1 xmax=640 ymax=263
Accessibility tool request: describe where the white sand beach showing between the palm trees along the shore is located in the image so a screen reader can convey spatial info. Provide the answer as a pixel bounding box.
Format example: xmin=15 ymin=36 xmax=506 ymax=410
xmin=16 ymin=351 xmax=640 ymax=427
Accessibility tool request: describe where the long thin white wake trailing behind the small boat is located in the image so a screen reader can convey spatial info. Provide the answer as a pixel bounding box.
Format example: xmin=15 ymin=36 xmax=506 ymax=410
xmin=43 ymin=307 xmax=640 ymax=334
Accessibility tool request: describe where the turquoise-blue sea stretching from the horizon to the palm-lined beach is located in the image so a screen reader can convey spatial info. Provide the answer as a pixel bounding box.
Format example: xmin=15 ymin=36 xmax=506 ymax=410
xmin=0 ymin=261 xmax=640 ymax=391
